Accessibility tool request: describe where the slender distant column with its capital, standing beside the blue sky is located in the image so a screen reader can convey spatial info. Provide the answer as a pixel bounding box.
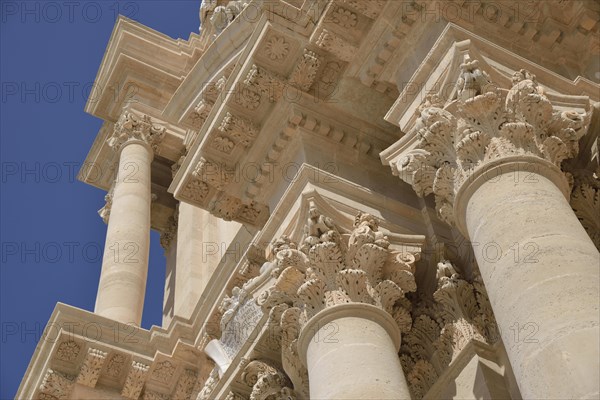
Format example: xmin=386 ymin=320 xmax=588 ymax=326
xmin=94 ymin=112 xmax=164 ymax=325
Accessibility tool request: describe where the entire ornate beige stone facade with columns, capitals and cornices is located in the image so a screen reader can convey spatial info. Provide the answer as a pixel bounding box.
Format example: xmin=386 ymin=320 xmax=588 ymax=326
xmin=17 ymin=0 xmax=600 ymax=400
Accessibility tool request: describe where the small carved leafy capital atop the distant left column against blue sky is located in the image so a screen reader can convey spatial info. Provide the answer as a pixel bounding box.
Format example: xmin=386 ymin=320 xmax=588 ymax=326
xmin=108 ymin=111 xmax=166 ymax=151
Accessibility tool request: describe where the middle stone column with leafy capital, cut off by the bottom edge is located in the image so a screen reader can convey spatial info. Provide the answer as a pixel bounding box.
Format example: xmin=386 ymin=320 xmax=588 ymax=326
xmin=259 ymin=207 xmax=416 ymax=400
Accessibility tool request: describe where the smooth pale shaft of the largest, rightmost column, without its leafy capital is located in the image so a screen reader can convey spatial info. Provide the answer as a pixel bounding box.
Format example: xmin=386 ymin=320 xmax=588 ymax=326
xmin=457 ymin=160 xmax=600 ymax=399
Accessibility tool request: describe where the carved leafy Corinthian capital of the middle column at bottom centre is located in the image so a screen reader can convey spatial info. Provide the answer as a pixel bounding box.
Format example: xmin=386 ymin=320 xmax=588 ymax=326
xmin=259 ymin=205 xmax=417 ymax=332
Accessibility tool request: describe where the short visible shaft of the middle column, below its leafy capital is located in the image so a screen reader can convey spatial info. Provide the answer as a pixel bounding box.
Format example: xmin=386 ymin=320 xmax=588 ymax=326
xmin=299 ymin=304 xmax=411 ymax=400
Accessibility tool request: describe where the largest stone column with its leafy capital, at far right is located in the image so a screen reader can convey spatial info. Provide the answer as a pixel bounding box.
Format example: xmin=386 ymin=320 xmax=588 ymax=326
xmin=393 ymin=59 xmax=600 ymax=399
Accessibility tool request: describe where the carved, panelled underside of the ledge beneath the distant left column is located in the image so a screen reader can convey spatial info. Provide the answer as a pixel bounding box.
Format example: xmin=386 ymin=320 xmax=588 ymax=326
xmin=30 ymin=332 xmax=213 ymax=400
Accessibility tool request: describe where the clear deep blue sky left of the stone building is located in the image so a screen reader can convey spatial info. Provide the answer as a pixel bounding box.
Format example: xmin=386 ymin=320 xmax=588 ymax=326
xmin=0 ymin=0 xmax=200 ymax=399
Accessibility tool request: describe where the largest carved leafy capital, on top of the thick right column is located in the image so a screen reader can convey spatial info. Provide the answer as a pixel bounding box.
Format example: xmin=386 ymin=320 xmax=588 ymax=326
xmin=395 ymin=56 xmax=590 ymax=224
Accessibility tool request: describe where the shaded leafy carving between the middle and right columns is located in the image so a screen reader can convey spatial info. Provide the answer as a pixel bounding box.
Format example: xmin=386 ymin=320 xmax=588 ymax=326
xmin=400 ymin=261 xmax=500 ymax=399
